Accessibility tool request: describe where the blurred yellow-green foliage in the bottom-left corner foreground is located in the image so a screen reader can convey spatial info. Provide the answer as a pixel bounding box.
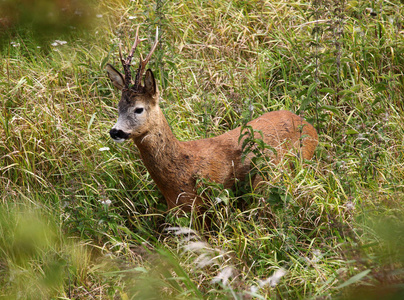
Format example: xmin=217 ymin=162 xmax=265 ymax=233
xmin=0 ymin=201 xmax=89 ymax=299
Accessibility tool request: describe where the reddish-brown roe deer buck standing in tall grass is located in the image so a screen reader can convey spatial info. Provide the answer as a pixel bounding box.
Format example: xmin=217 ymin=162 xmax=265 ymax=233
xmin=106 ymin=28 xmax=318 ymax=211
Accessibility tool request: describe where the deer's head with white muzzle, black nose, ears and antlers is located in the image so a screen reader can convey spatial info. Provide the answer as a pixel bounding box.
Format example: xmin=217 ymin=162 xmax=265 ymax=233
xmin=106 ymin=27 xmax=159 ymax=143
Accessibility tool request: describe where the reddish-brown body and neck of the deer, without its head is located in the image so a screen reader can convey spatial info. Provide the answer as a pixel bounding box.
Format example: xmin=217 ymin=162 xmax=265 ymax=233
xmin=134 ymin=107 xmax=317 ymax=210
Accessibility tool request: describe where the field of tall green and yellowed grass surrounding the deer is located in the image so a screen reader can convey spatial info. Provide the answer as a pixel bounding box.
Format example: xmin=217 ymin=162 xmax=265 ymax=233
xmin=0 ymin=0 xmax=404 ymax=299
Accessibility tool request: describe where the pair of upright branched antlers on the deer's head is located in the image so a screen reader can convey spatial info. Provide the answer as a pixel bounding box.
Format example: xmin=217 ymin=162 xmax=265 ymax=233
xmin=119 ymin=26 xmax=159 ymax=90
